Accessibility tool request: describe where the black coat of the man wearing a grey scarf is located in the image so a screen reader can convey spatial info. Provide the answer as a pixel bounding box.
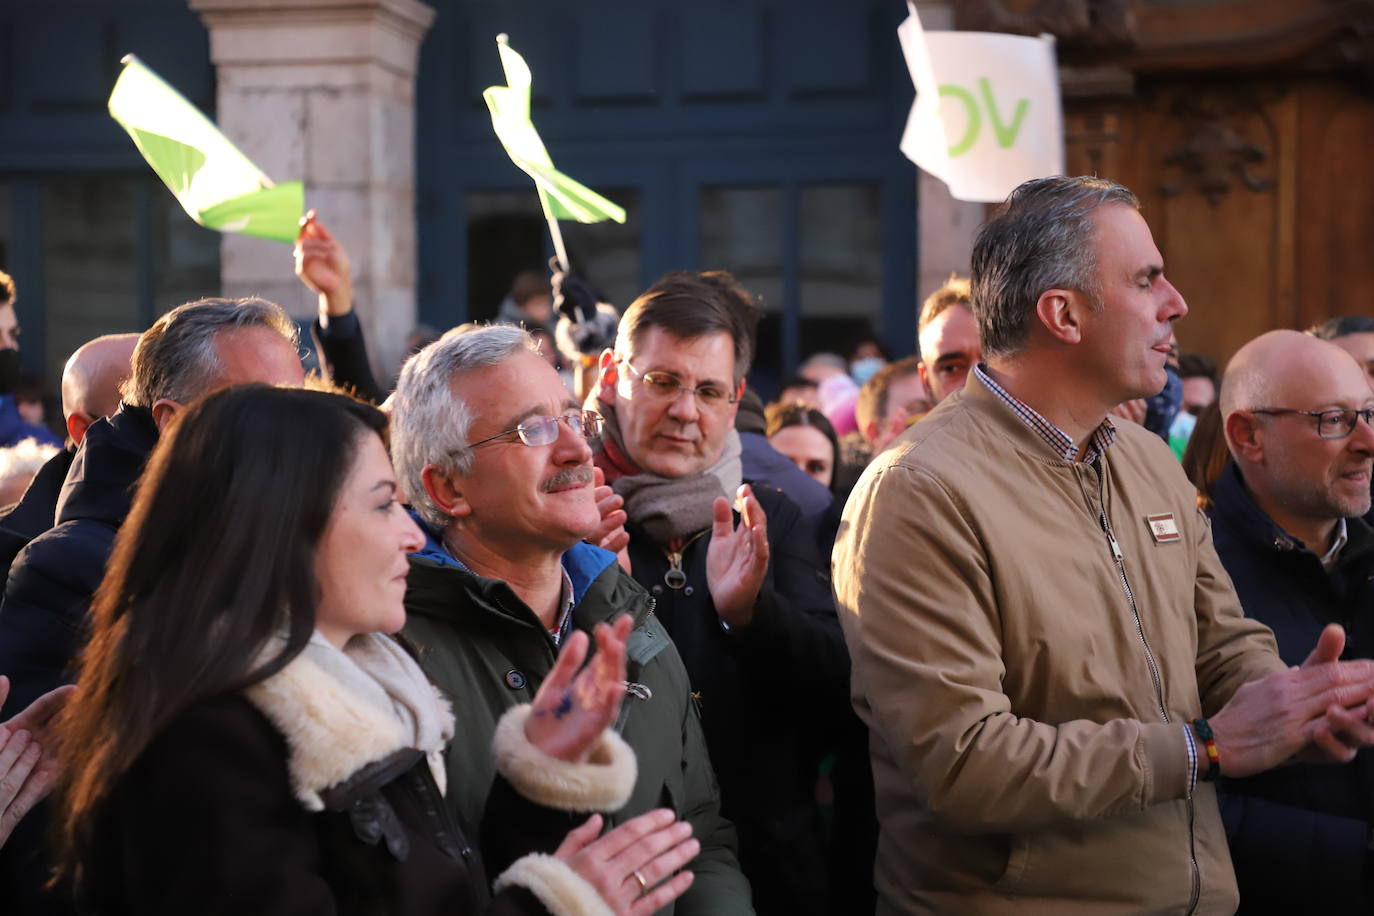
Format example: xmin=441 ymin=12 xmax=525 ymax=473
xmin=627 ymin=486 xmax=872 ymax=915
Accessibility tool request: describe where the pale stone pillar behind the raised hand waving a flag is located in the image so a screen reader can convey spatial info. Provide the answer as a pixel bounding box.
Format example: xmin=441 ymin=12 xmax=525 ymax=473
xmin=188 ymin=0 xmax=434 ymax=385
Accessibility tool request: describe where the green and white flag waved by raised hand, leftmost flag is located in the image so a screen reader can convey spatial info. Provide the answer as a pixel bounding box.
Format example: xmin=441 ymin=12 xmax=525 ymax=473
xmin=110 ymin=54 xmax=305 ymax=243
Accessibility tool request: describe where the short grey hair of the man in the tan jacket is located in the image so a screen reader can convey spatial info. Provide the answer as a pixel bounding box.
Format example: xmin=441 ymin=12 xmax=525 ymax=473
xmin=971 ymin=176 xmax=1140 ymax=356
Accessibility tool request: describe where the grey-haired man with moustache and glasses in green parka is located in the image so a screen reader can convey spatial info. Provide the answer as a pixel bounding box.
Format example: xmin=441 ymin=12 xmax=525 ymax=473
xmin=392 ymin=325 xmax=753 ymax=916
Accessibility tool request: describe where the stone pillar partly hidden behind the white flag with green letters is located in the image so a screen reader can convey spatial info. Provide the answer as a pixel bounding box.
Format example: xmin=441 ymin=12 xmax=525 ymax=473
xmin=916 ymin=0 xmax=985 ymax=299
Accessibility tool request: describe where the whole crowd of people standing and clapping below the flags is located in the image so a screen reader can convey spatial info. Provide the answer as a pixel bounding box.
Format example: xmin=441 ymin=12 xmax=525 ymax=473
xmin=0 ymin=177 xmax=1374 ymax=916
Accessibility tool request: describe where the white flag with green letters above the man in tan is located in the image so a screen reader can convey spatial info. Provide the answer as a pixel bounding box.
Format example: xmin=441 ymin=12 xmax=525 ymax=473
xmin=897 ymin=0 xmax=1063 ymax=202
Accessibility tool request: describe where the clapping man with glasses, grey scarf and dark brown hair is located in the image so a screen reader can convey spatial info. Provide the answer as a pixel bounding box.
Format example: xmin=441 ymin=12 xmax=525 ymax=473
xmin=588 ymin=272 xmax=872 ymax=916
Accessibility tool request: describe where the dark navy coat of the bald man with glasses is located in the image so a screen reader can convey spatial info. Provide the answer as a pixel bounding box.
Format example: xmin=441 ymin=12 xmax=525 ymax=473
xmin=1212 ymin=463 xmax=1374 ymax=913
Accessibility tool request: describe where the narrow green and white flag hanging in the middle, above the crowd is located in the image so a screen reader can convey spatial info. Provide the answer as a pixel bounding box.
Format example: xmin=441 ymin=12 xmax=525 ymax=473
xmin=482 ymin=34 xmax=625 ymax=222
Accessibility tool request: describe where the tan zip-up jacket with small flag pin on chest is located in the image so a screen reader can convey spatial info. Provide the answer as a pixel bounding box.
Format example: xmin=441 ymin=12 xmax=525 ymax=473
xmin=834 ymin=376 xmax=1283 ymax=915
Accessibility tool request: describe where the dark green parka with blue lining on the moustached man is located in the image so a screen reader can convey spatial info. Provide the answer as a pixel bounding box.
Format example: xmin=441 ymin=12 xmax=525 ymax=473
xmin=404 ymin=526 xmax=754 ymax=916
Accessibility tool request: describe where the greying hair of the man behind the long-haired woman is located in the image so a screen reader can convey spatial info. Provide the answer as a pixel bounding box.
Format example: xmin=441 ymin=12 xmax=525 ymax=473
xmin=120 ymin=298 xmax=301 ymax=407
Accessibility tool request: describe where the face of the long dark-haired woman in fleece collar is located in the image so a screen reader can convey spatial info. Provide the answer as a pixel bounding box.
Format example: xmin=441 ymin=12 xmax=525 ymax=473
xmin=315 ymin=433 xmax=425 ymax=648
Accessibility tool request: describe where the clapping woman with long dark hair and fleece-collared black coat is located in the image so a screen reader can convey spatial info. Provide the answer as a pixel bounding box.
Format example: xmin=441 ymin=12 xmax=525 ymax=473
xmin=58 ymin=386 xmax=697 ymax=916
